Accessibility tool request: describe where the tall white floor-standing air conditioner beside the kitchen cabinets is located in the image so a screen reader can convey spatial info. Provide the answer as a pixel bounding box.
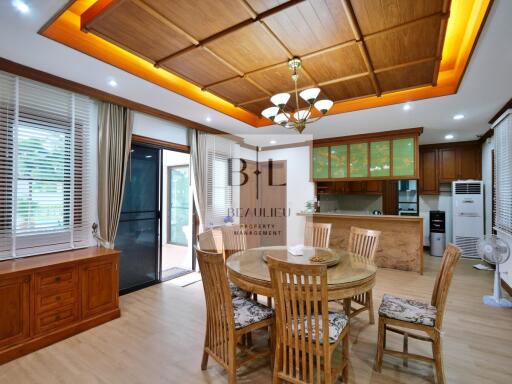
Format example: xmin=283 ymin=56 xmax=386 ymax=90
xmin=452 ymin=180 xmax=484 ymax=258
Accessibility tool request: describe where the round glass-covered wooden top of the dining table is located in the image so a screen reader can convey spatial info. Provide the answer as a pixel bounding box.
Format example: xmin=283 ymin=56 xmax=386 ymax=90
xmin=226 ymin=246 xmax=377 ymax=304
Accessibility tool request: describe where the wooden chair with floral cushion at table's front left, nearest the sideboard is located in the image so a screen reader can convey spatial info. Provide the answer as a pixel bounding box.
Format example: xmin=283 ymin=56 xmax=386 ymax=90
xmin=196 ymin=248 xmax=274 ymax=384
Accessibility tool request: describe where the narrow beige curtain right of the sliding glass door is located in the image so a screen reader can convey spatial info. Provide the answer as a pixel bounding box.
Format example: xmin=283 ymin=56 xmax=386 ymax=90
xmin=189 ymin=129 xmax=208 ymax=231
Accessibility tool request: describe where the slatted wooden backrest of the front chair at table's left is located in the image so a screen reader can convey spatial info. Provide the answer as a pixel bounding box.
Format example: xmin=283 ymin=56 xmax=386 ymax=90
xmin=196 ymin=248 xmax=235 ymax=368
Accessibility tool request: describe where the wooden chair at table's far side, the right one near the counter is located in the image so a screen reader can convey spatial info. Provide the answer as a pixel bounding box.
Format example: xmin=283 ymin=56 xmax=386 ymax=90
xmin=348 ymin=227 xmax=380 ymax=324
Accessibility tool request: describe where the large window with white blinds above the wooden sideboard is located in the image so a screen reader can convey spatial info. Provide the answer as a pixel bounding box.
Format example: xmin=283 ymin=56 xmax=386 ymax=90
xmin=0 ymin=72 xmax=94 ymax=258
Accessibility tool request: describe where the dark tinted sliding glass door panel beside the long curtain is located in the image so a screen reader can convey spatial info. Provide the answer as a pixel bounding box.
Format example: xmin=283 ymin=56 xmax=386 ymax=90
xmin=115 ymin=144 xmax=160 ymax=292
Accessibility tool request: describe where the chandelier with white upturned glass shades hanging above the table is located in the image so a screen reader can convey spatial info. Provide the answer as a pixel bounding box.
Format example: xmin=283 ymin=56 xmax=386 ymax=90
xmin=261 ymin=57 xmax=333 ymax=133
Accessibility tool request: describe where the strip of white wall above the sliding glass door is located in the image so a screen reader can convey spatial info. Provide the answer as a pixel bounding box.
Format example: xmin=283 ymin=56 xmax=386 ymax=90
xmin=133 ymin=112 xmax=188 ymax=145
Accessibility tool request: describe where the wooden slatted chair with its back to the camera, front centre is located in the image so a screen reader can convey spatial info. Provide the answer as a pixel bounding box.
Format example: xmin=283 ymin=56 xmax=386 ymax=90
xmin=268 ymin=257 xmax=349 ymax=384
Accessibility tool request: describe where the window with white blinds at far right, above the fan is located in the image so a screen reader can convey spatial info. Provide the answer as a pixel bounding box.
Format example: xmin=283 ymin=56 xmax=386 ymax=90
xmin=494 ymin=111 xmax=512 ymax=236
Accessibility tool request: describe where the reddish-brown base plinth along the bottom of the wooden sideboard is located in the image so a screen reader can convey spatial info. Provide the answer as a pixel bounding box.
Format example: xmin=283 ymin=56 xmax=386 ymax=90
xmin=0 ymin=308 xmax=121 ymax=365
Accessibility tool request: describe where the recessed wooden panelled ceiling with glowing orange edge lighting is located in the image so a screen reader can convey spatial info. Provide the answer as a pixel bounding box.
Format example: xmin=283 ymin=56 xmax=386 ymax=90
xmin=42 ymin=0 xmax=490 ymax=126
